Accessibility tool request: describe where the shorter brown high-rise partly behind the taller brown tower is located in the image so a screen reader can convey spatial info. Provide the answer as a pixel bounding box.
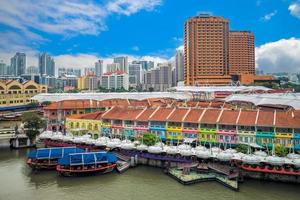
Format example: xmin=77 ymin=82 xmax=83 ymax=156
xmin=229 ymin=31 xmax=255 ymax=75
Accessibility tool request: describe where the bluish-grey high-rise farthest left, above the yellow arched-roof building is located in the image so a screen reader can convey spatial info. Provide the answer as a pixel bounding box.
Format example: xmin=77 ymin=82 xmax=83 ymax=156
xmin=9 ymin=52 xmax=26 ymax=76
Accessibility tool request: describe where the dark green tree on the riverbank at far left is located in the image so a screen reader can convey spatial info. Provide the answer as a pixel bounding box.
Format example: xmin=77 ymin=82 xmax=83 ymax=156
xmin=21 ymin=112 xmax=46 ymax=142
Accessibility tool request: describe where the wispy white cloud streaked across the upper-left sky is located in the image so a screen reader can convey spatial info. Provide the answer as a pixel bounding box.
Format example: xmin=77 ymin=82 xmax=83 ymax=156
xmin=0 ymin=0 xmax=162 ymax=52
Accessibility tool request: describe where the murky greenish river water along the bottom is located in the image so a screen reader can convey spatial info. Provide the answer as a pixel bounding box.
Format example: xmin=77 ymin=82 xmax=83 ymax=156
xmin=0 ymin=149 xmax=300 ymax=200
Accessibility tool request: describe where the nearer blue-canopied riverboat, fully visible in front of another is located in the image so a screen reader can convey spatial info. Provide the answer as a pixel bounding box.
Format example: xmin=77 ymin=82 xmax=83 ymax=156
xmin=56 ymin=151 xmax=118 ymax=176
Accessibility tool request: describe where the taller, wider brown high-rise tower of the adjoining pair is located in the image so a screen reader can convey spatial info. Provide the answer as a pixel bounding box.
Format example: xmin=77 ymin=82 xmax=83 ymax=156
xmin=184 ymin=14 xmax=231 ymax=85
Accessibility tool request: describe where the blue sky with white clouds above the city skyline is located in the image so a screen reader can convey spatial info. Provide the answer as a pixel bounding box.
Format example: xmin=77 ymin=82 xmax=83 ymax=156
xmin=0 ymin=0 xmax=300 ymax=72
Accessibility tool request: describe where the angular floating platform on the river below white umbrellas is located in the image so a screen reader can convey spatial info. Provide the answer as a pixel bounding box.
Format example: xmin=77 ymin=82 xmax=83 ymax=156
xmin=167 ymin=168 xmax=239 ymax=191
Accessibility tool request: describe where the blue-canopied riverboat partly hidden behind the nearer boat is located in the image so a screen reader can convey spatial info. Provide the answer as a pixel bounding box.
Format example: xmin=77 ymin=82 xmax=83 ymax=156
xmin=27 ymin=147 xmax=84 ymax=169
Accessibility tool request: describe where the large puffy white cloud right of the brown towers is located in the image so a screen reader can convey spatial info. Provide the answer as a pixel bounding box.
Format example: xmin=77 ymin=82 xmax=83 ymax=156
xmin=256 ymin=38 xmax=300 ymax=73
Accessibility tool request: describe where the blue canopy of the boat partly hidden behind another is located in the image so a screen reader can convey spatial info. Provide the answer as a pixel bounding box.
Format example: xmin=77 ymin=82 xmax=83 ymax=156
xmin=28 ymin=147 xmax=85 ymax=159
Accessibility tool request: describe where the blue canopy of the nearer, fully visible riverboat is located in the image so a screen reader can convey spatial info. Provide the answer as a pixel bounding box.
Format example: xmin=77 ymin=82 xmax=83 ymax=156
xmin=58 ymin=151 xmax=118 ymax=165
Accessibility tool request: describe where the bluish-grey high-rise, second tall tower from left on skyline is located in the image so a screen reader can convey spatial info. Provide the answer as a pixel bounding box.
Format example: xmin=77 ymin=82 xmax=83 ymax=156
xmin=39 ymin=53 xmax=55 ymax=76
